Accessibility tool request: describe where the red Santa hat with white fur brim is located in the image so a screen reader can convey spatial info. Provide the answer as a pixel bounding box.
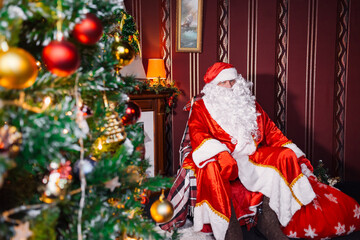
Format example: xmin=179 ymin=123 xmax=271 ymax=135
xmin=204 ymin=62 xmax=238 ymax=84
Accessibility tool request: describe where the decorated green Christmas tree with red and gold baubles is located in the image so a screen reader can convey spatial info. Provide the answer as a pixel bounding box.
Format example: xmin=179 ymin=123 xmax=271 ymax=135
xmin=0 ymin=0 xmax=171 ymax=240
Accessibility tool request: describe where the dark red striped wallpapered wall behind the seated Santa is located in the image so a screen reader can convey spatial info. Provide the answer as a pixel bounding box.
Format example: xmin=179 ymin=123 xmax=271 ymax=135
xmin=125 ymin=0 xmax=360 ymax=181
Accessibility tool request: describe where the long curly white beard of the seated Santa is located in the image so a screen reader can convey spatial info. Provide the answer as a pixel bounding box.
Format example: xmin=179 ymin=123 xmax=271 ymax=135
xmin=201 ymin=75 xmax=259 ymax=146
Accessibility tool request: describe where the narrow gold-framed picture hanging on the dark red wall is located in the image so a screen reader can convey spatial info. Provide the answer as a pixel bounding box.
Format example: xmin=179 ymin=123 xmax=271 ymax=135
xmin=176 ymin=0 xmax=203 ymax=52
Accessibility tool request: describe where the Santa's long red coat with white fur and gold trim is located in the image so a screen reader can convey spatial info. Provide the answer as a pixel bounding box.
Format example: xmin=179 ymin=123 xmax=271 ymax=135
xmin=183 ymin=100 xmax=356 ymax=239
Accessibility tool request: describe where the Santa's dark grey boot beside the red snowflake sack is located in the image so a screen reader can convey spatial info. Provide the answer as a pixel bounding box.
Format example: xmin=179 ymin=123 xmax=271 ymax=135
xmin=257 ymin=196 xmax=289 ymax=240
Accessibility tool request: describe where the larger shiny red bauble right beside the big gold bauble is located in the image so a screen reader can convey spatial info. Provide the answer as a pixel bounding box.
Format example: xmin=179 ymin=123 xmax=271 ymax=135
xmin=42 ymin=40 xmax=80 ymax=77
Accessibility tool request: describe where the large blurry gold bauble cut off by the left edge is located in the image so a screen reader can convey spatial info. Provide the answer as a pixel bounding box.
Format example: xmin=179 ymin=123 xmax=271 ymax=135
xmin=0 ymin=48 xmax=38 ymax=89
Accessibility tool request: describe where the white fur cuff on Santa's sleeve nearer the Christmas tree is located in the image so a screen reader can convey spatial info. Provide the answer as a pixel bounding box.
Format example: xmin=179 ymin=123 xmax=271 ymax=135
xmin=192 ymin=139 xmax=230 ymax=168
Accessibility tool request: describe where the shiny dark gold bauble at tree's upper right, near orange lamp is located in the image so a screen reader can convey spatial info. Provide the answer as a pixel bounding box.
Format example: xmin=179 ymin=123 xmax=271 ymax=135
xmin=111 ymin=37 xmax=135 ymax=71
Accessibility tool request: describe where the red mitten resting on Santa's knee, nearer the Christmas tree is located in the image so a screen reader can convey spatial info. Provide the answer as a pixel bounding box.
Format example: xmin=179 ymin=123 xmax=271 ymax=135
xmin=216 ymin=151 xmax=239 ymax=181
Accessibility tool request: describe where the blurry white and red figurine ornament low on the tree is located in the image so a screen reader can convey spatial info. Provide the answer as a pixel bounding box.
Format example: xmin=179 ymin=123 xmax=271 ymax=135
xmin=40 ymin=161 xmax=72 ymax=203
